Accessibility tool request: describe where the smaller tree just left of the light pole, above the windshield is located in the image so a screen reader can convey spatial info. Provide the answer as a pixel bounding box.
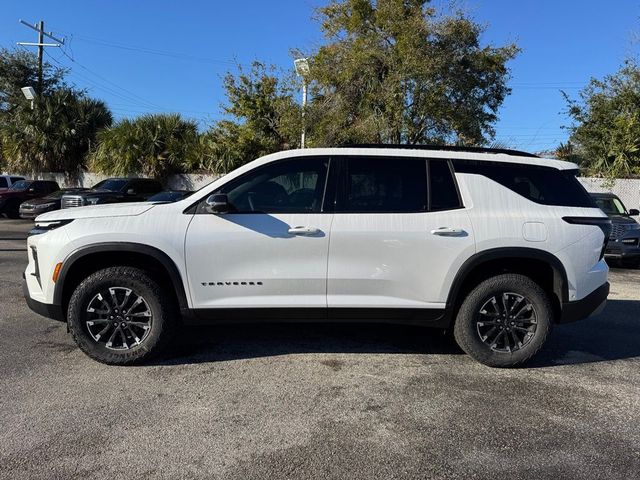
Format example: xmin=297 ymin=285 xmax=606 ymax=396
xmin=202 ymin=62 xmax=301 ymax=172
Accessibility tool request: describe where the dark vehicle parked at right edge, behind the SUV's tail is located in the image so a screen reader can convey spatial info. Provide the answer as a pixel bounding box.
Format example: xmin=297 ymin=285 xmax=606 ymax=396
xmin=591 ymin=193 xmax=640 ymax=267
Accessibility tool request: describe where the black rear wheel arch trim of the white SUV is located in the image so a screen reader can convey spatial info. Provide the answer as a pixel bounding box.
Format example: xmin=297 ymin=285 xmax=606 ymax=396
xmin=447 ymin=247 xmax=569 ymax=323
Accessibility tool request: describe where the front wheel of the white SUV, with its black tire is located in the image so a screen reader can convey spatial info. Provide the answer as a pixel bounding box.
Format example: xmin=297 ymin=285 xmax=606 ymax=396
xmin=67 ymin=267 xmax=178 ymax=365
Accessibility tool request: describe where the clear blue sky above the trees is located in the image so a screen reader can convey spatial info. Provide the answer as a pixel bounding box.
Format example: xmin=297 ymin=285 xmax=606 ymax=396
xmin=0 ymin=0 xmax=640 ymax=152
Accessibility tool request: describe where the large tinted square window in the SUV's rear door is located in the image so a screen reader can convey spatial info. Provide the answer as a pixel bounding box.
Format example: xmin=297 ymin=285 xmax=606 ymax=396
xmin=338 ymin=157 xmax=427 ymax=213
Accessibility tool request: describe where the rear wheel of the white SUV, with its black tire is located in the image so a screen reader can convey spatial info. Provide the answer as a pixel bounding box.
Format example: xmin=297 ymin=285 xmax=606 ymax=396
xmin=454 ymin=274 xmax=553 ymax=367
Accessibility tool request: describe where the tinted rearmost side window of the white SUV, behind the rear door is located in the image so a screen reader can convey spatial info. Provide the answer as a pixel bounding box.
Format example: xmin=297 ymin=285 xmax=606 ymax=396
xmin=453 ymin=160 xmax=596 ymax=208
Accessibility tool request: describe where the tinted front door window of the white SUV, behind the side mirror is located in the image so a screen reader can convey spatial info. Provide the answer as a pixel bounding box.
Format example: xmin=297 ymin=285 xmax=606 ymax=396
xmin=219 ymin=157 xmax=329 ymax=213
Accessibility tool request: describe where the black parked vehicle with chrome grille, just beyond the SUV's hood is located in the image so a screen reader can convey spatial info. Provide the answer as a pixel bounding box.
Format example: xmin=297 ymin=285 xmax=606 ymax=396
xmin=62 ymin=178 xmax=162 ymax=208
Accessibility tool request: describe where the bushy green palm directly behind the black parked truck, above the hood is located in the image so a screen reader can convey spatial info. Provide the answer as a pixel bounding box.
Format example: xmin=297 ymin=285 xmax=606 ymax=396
xmin=90 ymin=114 xmax=199 ymax=178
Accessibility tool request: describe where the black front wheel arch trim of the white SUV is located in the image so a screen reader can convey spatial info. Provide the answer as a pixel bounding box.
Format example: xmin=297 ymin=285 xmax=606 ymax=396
xmin=53 ymin=242 xmax=189 ymax=317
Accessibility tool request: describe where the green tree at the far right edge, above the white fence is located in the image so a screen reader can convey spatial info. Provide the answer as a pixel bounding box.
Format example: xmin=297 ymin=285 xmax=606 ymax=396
xmin=565 ymin=60 xmax=640 ymax=178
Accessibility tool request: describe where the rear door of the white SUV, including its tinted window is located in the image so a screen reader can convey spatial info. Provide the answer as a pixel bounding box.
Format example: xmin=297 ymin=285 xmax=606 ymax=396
xmin=327 ymin=156 xmax=475 ymax=309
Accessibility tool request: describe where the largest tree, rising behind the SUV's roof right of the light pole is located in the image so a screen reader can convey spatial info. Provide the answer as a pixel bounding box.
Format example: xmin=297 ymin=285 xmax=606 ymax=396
xmin=309 ymin=0 xmax=518 ymax=146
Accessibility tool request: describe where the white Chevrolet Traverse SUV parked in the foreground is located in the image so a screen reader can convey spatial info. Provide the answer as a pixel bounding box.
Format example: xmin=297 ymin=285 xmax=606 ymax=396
xmin=25 ymin=146 xmax=611 ymax=366
